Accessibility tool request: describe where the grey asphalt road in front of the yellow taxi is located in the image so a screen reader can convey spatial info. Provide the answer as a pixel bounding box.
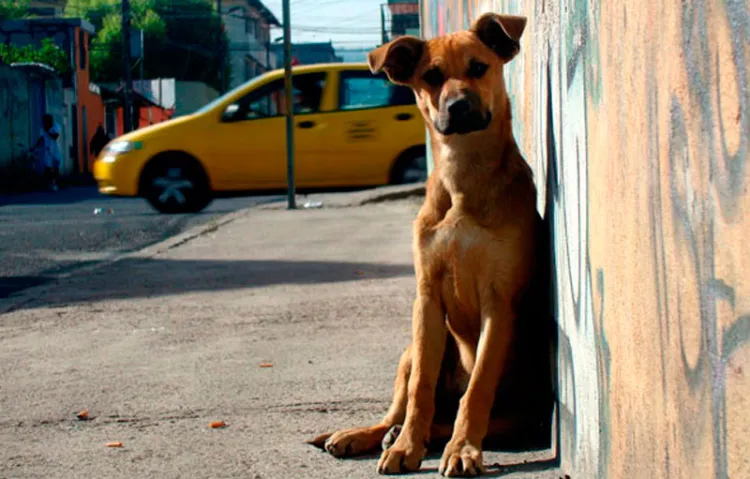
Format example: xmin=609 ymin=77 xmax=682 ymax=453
xmin=0 ymin=187 xmax=281 ymax=298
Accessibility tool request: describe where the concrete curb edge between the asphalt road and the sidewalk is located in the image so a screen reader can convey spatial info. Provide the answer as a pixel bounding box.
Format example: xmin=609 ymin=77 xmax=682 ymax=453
xmin=0 ymin=205 xmax=254 ymax=316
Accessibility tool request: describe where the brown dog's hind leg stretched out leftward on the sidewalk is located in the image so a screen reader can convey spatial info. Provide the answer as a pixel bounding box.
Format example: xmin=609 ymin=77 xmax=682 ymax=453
xmin=308 ymin=346 xmax=411 ymax=457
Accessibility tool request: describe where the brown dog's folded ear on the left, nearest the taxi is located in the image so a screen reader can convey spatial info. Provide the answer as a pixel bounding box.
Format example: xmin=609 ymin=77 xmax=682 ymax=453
xmin=367 ymin=35 xmax=424 ymax=83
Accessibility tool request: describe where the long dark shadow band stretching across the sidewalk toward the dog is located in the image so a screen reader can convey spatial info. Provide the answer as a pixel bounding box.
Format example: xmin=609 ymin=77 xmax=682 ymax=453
xmin=0 ymin=259 xmax=414 ymax=309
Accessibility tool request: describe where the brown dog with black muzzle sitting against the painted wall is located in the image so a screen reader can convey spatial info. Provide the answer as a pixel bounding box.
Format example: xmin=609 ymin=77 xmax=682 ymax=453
xmin=310 ymin=14 xmax=552 ymax=476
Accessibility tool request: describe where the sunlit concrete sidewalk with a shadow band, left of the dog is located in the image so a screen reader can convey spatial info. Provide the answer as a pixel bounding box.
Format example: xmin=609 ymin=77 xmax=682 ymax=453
xmin=0 ymin=190 xmax=558 ymax=478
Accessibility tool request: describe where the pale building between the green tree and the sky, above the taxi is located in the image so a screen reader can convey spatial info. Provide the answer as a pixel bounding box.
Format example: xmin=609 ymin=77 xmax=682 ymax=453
xmin=222 ymin=0 xmax=281 ymax=88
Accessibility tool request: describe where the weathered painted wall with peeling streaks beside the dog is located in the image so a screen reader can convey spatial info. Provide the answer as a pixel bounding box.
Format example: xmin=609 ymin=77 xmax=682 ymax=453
xmin=422 ymin=0 xmax=750 ymax=478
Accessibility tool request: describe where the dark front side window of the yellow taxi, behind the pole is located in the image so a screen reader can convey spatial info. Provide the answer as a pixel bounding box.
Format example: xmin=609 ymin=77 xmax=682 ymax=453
xmin=222 ymin=72 xmax=326 ymax=122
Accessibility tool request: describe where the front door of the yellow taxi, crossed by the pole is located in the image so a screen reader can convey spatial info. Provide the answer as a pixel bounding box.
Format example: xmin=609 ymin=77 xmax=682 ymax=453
xmin=209 ymin=72 xmax=332 ymax=190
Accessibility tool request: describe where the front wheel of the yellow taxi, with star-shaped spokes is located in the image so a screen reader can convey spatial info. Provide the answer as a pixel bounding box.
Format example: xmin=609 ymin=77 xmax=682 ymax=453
xmin=141 ymin=155 xmax=212 ymax=214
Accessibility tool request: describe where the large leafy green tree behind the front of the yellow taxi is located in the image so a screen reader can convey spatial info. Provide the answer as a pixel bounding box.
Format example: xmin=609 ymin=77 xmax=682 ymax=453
xmin=66 ymin=0 xmax=229 ymax=92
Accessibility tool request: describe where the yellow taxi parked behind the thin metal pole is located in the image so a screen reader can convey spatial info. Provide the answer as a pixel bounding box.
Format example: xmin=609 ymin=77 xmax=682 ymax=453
xmin=94 ymin=63 xmax=427 ymax=213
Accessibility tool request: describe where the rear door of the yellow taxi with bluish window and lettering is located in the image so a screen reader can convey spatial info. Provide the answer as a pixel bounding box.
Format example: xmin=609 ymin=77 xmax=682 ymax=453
xmin=326 ymin=69 xmax=424 ymax=186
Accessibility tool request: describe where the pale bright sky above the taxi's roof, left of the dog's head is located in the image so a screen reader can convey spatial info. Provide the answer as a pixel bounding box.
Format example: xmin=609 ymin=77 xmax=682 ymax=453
xmin=263 ymin=0 xmax=386 ymax=49
